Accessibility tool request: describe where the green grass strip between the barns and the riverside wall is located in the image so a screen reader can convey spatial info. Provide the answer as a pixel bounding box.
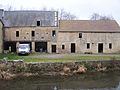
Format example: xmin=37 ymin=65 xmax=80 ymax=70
xmin=0 ymin=53 xmax=120 ymax=62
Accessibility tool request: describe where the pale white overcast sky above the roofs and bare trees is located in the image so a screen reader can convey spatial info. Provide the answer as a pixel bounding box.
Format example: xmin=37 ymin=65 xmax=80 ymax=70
xmin=0 ymin=0 xmax=120 ymax=24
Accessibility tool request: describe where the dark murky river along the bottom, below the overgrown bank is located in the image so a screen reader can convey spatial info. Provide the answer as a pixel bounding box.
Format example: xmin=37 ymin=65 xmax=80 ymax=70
xmin=0 ymin=71 xmax=120 ymax=90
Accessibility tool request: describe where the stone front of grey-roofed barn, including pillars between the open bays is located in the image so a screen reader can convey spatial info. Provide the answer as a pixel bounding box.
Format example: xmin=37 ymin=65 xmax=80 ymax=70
xmin=5 ymin=27 xmax=57 ymax=52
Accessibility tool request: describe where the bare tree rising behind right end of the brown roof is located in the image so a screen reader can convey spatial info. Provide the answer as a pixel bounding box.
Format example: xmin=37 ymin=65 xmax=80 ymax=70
xmin=90 ymin=13 xmax=114 ymax=20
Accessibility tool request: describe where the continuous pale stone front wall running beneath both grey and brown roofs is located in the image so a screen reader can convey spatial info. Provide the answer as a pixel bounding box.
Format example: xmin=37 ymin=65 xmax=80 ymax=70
xmin=5 ymin=27 xmax=120 ymax=53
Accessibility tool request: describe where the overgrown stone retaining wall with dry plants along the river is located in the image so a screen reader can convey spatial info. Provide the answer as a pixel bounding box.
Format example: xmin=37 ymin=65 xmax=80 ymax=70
xmin=0 ymin=60 xmax=120 ymax=79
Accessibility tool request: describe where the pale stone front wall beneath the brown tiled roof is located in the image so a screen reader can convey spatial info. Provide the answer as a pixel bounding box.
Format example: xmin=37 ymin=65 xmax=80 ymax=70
xmin=57 ymin=31 xmax=120 ymax=53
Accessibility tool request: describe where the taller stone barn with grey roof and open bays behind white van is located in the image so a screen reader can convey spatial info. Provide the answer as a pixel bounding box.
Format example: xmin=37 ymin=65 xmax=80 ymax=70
xmin=1 ymin=10 xmax=58 ymax=52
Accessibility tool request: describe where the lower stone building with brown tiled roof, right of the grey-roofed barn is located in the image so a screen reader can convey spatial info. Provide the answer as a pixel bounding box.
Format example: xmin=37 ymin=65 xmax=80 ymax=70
xmin=57 ymin=20 xmax=120 ymax=53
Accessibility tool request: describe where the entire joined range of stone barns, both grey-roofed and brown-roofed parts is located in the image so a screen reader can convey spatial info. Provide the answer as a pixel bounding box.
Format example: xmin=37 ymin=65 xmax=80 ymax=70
xmin=0 ymin=10 xmax=120 ymax=53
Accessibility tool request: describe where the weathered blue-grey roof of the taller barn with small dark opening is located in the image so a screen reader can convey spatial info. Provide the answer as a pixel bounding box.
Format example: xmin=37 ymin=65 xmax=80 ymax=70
xmin=0 ymin=10 xmax=56 ymax=27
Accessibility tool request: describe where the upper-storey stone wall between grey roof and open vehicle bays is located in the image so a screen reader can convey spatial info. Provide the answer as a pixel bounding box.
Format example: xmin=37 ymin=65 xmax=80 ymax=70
xmin=5 ymin=27 xmax=57 ymax=41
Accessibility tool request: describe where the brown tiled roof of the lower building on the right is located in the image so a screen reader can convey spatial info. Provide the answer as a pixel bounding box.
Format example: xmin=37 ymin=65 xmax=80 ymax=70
xmin=59 ymin=20 xmax=120 ymax=32
